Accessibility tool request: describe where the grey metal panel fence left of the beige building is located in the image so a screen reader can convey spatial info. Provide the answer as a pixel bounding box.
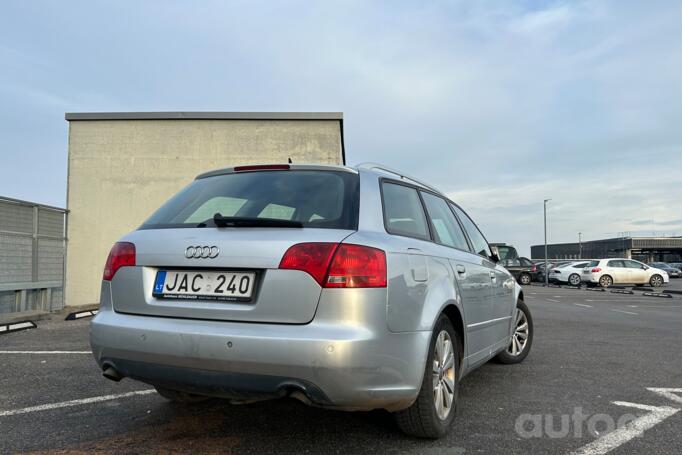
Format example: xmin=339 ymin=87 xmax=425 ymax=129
xmin=0 ymin=197 xmax=66 ymax=319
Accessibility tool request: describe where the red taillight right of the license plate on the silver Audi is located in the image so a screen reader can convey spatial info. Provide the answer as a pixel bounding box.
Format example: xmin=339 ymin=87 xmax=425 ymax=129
xmin=279 ymin=242 xmax=386 ymax=288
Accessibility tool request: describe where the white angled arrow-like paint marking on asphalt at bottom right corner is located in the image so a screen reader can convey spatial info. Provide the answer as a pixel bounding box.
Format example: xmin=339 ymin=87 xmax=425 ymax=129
xmin=571 ymin=401 xmax=680 ymax=455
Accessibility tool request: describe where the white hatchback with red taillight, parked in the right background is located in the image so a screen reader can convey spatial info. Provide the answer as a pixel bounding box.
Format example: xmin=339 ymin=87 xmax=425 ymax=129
xmin=581 ymin=258 xmax=670 ymax=288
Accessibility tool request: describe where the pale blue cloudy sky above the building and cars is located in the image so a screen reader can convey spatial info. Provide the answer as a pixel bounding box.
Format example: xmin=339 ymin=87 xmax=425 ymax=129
xmin=0 ymin=0 xmax=682 ymax=254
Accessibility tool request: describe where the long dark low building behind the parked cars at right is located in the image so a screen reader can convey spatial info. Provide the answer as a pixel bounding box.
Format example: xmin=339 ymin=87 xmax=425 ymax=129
xmin=530 ymin=237 xmax=682 ymax=262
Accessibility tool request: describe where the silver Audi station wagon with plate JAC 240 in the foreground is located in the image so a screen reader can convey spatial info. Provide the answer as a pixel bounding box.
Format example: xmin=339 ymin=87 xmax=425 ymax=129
xmin=91 ymin=164 xmax=533 ymax=438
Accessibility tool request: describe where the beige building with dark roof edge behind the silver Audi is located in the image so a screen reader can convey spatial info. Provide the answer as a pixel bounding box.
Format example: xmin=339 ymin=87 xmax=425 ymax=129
xmin=65 ymin=113 xmax=344 ymax=306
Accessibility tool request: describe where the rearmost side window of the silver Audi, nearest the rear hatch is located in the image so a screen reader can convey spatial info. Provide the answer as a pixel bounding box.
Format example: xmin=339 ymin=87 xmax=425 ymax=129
xmin=382 ymin=182 xmax=430 ymax=240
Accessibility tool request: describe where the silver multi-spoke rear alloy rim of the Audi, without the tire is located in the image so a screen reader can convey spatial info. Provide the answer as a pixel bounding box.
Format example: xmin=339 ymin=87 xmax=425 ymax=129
xmin=432 ymin=330 xmax=456 ymax=420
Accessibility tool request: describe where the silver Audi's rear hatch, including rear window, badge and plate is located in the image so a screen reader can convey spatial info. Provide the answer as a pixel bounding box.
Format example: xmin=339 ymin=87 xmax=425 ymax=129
xmin=111 ymin=166 xmax=359 ymax=324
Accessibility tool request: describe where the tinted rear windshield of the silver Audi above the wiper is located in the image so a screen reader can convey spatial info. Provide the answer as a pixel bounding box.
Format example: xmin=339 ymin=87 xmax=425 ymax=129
xmin=140 ymin=170 xmax=359 ymax=230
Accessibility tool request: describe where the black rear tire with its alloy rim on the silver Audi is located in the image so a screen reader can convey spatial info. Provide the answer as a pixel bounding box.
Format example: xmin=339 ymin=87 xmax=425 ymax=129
xmin=395 ymin=314 xmax=461 ymax=439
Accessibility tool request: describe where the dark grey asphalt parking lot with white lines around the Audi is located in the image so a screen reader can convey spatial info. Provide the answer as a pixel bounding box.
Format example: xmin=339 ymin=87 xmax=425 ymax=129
xmin=0 ymin=286 xmax=682 ymax=454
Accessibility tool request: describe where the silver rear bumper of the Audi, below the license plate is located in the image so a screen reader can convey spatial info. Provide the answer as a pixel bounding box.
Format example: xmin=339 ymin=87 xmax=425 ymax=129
xmin=90 ymin=308 xmax=431 ymax=411
